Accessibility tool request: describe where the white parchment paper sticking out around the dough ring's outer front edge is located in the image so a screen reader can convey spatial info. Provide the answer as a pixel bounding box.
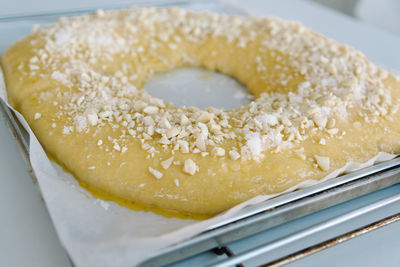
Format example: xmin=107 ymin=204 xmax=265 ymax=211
xmin=0 ymin=63 xmax=395 ymax=267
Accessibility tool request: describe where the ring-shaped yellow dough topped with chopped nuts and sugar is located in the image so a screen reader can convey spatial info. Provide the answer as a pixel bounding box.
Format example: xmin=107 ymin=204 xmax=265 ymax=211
xmin=2 ymin=8 xmax=400 ymax=215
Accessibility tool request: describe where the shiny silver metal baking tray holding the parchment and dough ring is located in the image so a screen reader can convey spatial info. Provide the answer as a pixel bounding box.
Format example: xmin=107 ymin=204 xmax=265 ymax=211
xmin=0 ymin=1 xmax=400 ymax=266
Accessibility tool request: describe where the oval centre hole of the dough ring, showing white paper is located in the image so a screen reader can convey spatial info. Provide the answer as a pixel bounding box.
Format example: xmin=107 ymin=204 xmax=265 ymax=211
xmin=143 ymin=67 xmax=253 ymax=109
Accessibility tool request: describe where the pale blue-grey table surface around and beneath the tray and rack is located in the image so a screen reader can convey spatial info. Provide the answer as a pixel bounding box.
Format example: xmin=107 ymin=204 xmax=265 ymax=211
xmin=0 ymin=0 xmax=400 ymax=267
